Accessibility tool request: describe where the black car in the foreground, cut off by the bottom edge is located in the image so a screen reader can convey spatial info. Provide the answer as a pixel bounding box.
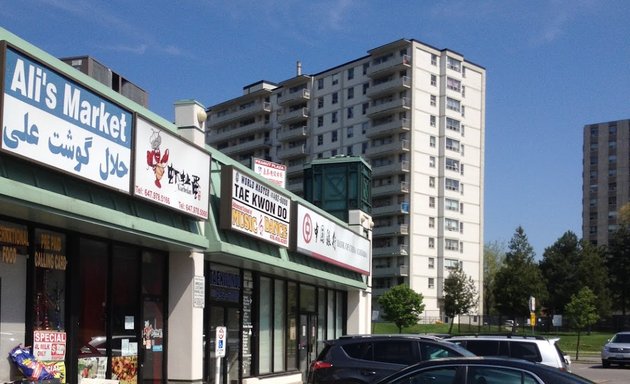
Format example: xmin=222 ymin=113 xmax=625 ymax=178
xmin=377 ymin=357 xmax=594 ymax=384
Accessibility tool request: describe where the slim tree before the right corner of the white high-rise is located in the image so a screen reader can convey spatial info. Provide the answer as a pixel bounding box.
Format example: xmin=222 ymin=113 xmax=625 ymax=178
xmin=444 ymin=264 xmax=479 ymax=333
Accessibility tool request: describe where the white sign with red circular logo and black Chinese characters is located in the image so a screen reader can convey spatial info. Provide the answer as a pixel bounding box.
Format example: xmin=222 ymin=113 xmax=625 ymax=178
xmin=295 ymin=204 xmax=370 ymax=275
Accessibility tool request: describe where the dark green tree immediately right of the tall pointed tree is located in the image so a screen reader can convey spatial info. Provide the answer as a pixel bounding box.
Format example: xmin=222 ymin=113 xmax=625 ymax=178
xmin=539 ymin=231 xmax=582 ymax=315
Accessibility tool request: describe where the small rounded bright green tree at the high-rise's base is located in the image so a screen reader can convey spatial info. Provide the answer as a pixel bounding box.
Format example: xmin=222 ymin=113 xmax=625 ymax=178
xmin=378 ymin=284 xmax=424 ymax=333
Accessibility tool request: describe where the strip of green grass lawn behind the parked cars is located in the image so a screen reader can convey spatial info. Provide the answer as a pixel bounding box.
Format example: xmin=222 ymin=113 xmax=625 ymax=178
xmin=372 ymin=323 xmax=613 ymax=359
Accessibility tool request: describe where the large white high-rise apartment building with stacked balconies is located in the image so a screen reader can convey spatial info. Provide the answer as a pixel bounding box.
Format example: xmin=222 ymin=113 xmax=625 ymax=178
xmin=206 ymin=39 xmax=486 ymax=321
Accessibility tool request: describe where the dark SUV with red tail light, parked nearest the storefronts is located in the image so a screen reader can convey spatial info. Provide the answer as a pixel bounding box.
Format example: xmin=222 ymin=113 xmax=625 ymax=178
xmin=308 ymin=334 xmax=474 ymax=384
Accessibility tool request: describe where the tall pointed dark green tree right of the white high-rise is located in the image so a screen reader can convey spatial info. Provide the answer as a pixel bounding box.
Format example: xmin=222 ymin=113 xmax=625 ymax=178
xmin=494 ymin=226 xmax=547 ymax=327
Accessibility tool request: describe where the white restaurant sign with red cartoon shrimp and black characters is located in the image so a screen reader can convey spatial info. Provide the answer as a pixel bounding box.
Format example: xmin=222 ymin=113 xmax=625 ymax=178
xmin=134 ymin=117 xmax=210 ymax=219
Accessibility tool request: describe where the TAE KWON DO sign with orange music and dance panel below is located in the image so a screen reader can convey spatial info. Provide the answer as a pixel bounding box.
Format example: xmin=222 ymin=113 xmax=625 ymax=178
xmin=220 ymin=166 xmax=291 ymax=247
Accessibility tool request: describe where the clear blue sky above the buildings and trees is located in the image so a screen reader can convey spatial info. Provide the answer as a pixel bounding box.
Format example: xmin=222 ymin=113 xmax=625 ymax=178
xmin=0 ymin=0 xmax=630 ymax=257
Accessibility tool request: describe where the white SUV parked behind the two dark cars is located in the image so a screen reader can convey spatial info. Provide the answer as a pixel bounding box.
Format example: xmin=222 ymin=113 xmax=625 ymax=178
xmin=447 ymin=334 xmax=571 ymax=371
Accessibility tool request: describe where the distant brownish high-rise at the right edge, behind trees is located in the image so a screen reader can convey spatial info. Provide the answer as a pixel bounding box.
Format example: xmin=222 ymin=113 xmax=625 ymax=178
xmin=582 ymin=120 xmax=630 ymax=245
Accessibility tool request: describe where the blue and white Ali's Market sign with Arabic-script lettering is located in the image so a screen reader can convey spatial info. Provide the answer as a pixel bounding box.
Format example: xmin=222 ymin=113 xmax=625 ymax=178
xmin=2 ymin=47 xmax=132 ymax=193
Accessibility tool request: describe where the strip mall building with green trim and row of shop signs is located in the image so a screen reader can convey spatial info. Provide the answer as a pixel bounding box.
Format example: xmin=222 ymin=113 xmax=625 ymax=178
xmin=0 ymin=29 xmax=371 ymax=384
